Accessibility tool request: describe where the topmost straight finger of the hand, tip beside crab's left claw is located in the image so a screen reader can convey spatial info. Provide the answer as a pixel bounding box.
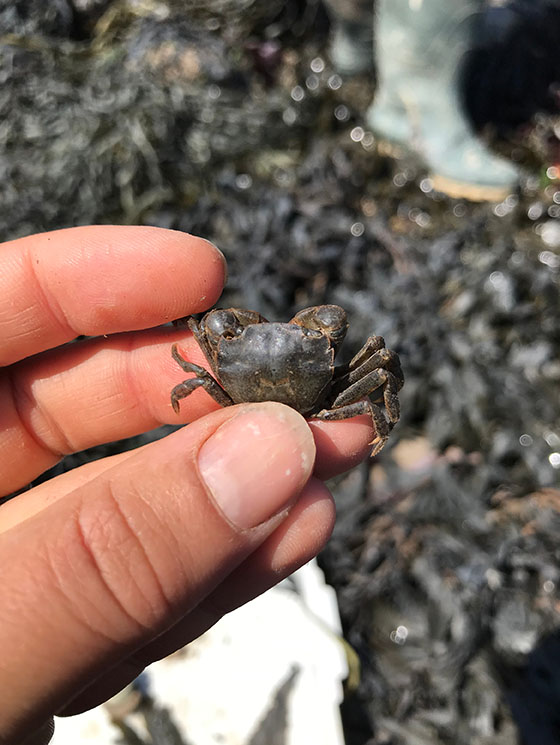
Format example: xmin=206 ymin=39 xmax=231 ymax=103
xmin=0 ymin=225 xmax=225 ymax=366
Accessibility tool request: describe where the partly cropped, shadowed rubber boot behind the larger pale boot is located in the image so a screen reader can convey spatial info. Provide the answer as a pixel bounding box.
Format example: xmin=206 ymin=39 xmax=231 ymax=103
xmin=325 ymin=0 xmax=374 ymax=75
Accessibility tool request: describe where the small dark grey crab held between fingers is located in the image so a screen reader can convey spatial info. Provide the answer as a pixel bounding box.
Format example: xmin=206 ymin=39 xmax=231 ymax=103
xmin=171 ymin=305 xmax=404 ymax=454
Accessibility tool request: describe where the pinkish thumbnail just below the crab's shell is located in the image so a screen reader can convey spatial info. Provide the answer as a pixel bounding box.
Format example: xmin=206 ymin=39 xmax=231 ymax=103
xmin=198 ymin=403 xmax=315 ymax=529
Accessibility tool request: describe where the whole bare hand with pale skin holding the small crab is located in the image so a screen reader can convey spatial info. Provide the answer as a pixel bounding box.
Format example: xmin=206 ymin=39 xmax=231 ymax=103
xmin=0 ymin=226 xmax=374 ymax=745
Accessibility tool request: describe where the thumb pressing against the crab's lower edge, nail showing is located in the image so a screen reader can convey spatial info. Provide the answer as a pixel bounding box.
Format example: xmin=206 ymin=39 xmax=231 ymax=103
xmin=0 ymin=403 xmax=315 ymax=745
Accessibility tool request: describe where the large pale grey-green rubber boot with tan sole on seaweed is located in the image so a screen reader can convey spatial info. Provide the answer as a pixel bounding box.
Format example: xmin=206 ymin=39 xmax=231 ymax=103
xmin=367 ymin=0 xmax=518 ymax=201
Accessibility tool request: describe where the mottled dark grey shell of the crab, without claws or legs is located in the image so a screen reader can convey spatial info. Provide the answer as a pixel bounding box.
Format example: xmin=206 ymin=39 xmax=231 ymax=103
xmin=217 ymin=323 xmax=334 ymax=414
